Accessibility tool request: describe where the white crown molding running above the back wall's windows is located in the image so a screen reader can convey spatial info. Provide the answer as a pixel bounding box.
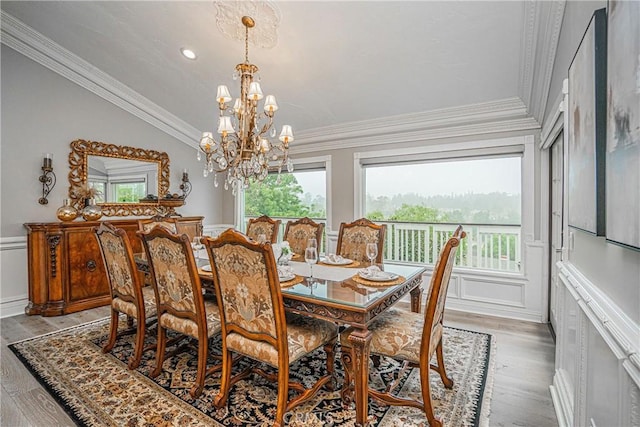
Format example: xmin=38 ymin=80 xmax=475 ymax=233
xmin=291 ymin=98 xmax=540 ymax=154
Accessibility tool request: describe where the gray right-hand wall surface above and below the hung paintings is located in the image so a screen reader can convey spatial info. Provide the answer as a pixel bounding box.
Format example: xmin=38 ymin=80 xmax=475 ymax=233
xmin=548 ymin=2 xmax=640 ymax=323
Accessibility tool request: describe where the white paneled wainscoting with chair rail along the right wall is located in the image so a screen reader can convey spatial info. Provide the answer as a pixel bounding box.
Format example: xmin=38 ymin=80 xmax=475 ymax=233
xmin=550 ymin=262 xmax=640 ymax=427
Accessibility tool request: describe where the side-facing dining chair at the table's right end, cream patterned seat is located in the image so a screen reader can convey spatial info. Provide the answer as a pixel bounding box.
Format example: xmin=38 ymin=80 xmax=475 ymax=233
xmin=340 ymin=226 xmax=466 ymax=426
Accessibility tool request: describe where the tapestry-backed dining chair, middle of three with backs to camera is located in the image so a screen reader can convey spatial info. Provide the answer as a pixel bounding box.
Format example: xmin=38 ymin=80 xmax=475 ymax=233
xmin=138 ymin=227 xmax=221 ymax=398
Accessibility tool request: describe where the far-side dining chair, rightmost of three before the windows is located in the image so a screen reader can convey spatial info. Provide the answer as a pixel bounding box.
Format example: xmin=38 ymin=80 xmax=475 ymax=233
xmin=336 ymin=218 xmax=387 ymax=263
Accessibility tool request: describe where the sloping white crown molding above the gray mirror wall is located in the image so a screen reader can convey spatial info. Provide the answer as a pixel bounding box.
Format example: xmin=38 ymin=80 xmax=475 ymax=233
xmin=0 ymin=11 xmax=200 ymax=147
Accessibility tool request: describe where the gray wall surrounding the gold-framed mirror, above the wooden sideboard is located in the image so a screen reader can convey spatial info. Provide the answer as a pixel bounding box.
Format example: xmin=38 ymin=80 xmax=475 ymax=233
xmin=0 ymin=45 xmax=222 ymax=237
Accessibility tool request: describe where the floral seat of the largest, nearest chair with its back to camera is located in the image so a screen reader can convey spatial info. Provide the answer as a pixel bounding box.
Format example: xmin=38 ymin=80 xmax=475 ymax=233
xmin=227 ymin=314 xmax=338 ymax=368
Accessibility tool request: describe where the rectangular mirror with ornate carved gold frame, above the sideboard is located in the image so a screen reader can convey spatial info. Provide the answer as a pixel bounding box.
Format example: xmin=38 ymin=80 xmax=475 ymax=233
xmin=69 ymin=139 xmax=177 ymax=216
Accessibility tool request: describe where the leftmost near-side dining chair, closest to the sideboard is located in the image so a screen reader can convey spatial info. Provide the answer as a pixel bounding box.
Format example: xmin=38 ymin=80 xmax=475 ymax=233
xmin=94 ymin=222 xmax=156 ymax=369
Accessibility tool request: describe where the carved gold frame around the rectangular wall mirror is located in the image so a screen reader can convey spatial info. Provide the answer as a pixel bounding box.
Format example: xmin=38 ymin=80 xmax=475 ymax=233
xmin=69 ymin=139 xmax=170 ymax=216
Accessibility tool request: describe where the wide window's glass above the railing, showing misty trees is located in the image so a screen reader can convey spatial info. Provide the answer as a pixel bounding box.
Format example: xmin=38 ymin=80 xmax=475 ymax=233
xmin=365 ymin=156 xmax=521 ymax=225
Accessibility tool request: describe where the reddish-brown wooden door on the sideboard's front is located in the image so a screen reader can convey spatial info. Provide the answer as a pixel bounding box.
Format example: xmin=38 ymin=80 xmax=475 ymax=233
xmin=67 ymin=227 xmax=110 ymax=303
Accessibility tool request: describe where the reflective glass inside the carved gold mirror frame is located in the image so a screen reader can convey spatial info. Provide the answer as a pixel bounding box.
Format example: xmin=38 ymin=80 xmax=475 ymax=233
xmin=87 ymin=156 xmax=158 ymax=203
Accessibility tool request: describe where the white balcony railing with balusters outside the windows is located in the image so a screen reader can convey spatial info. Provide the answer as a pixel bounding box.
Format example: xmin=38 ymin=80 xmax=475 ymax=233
xmin=246 ymin=217 xmax=522 ymax=273
